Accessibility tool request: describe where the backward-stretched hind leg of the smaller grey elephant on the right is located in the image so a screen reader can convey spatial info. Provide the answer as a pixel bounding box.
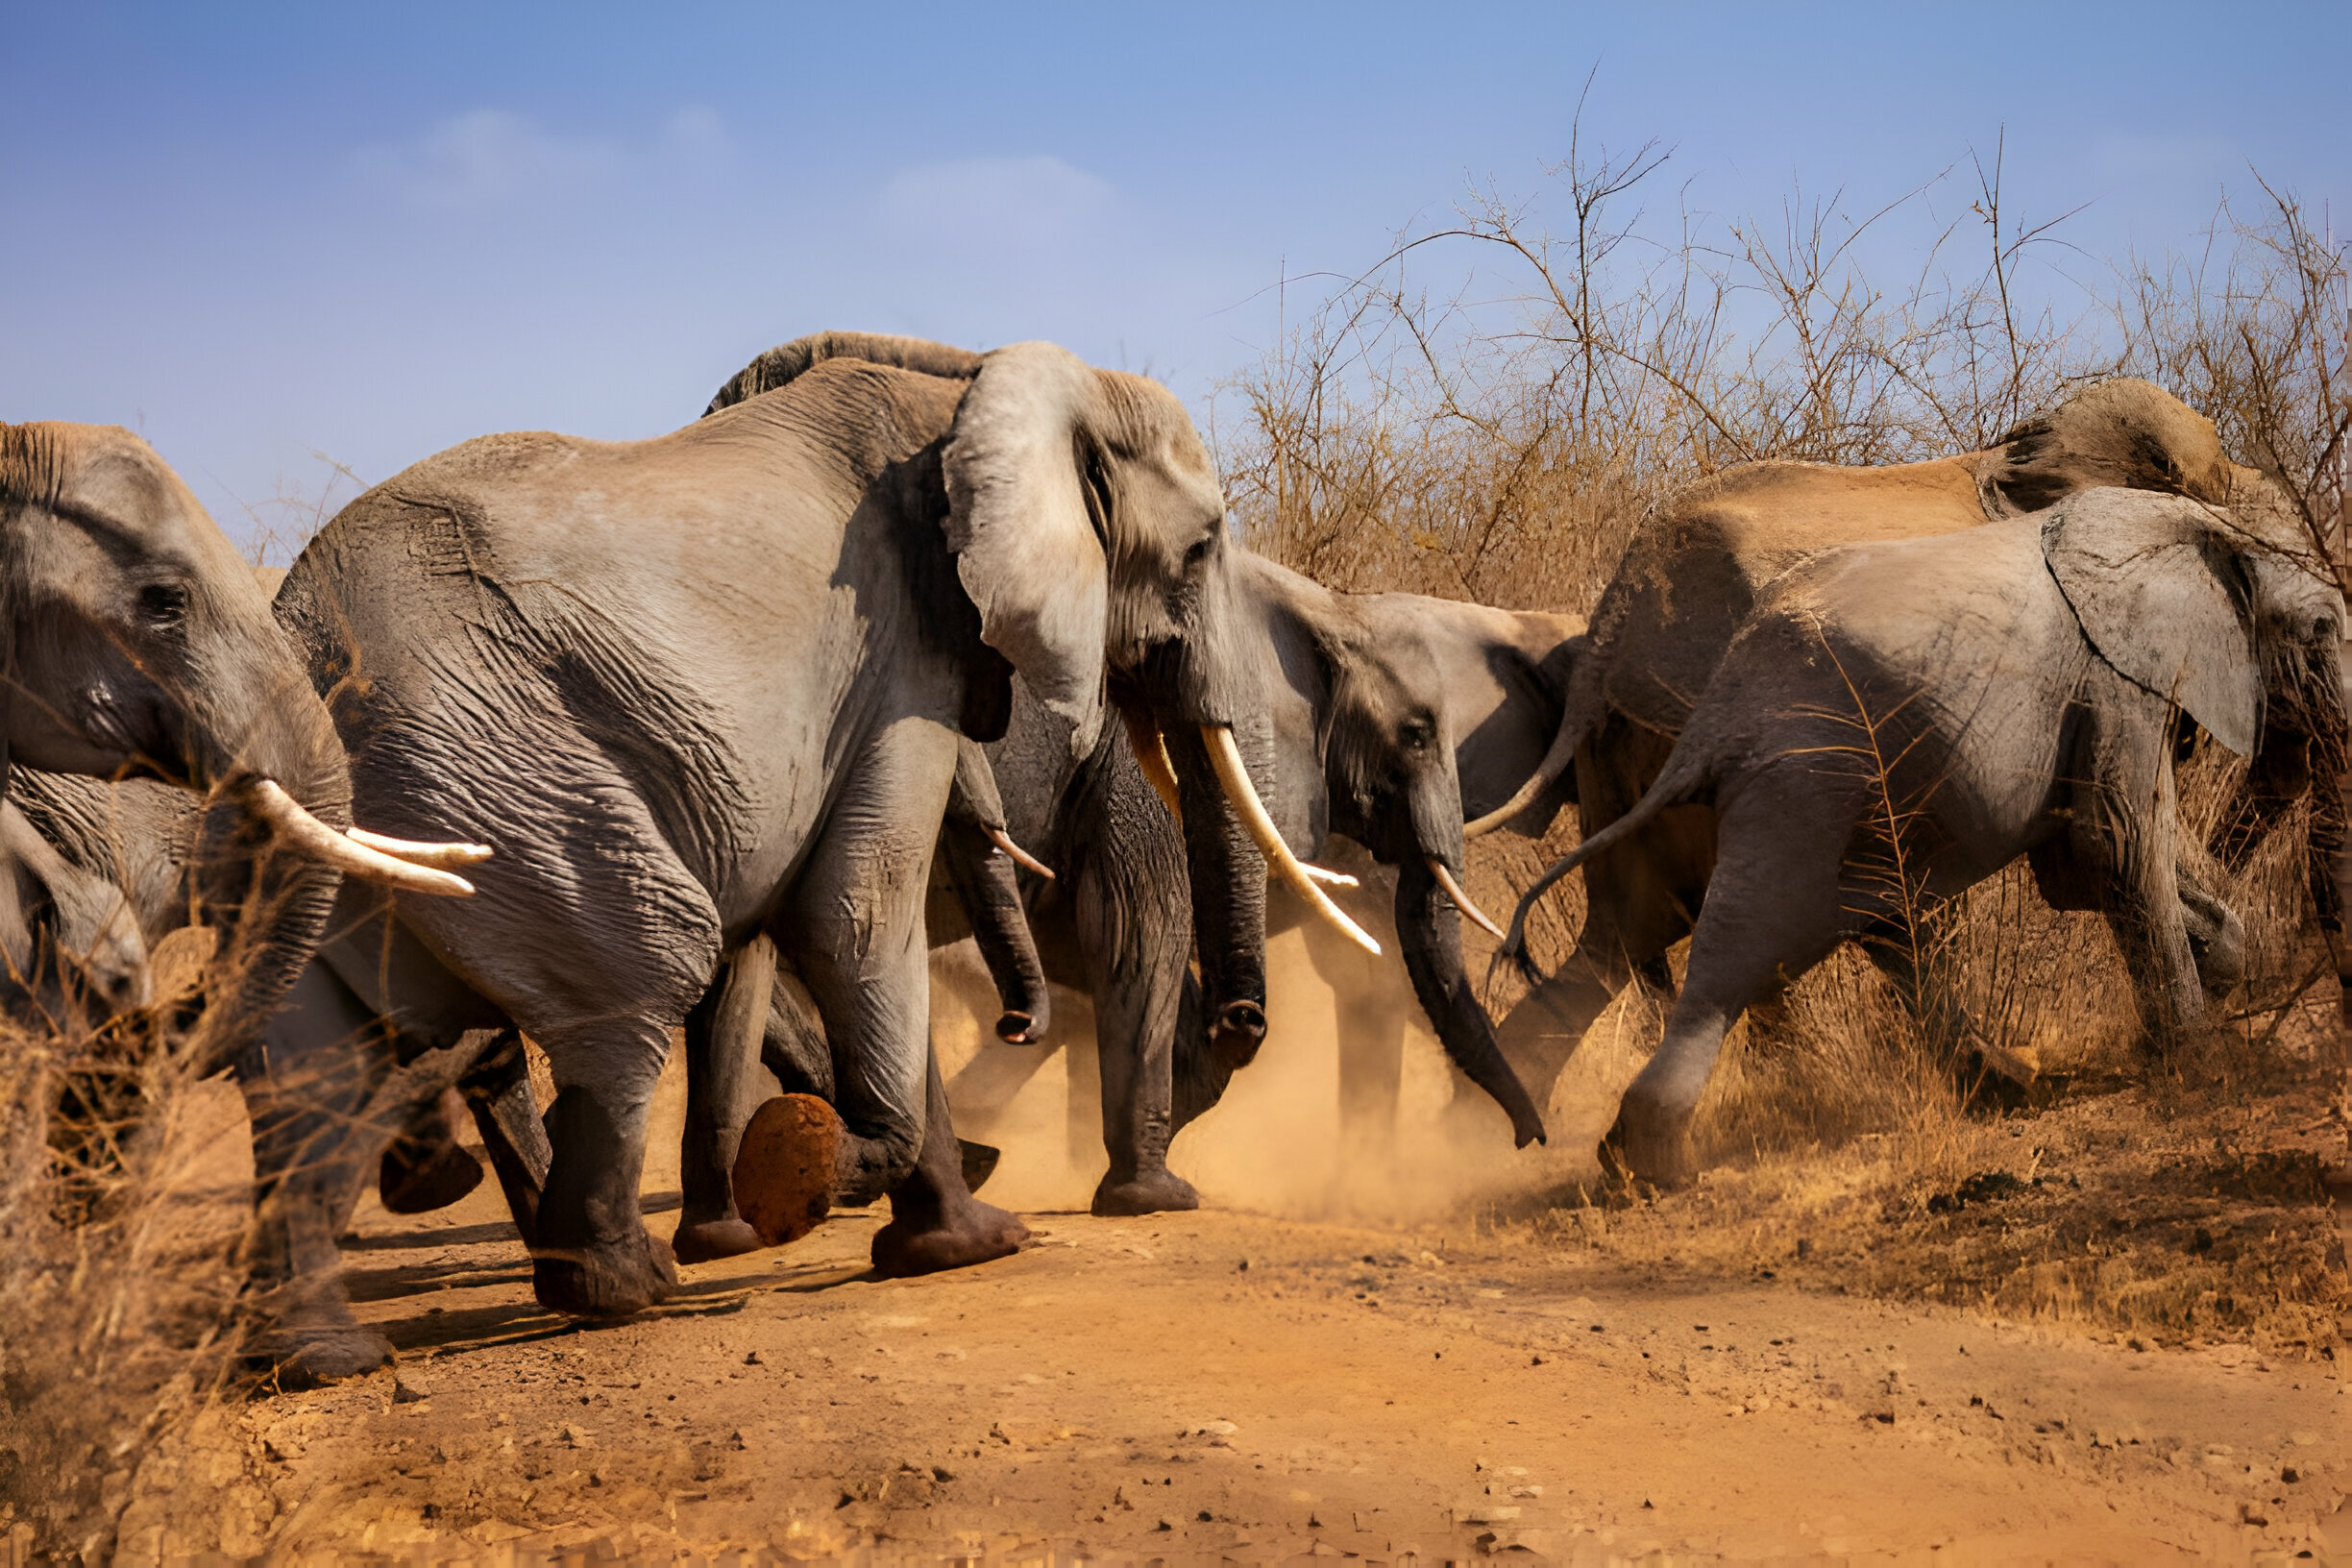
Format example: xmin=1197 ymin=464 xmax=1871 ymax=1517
xmin=1602 ymin=767 xmax=1853 ymax=1189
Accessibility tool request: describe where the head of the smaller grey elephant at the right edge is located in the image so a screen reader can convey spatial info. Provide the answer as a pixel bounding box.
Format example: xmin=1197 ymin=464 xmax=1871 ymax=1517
xmin=2042 ymin=489 xmax=2345 ymax=798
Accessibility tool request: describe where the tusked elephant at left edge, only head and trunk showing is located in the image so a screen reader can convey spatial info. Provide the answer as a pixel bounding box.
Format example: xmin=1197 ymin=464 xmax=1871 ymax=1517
xmin=0 ymin=423 xmax=471 ymax=1065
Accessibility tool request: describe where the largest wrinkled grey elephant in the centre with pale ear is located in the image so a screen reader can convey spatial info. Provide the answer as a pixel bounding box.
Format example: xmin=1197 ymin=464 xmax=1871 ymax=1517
xmin=255 ymin=331 xmax=1263 ymax=1375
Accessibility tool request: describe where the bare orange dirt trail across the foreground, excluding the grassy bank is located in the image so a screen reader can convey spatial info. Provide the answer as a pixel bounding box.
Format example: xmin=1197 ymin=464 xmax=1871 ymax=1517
xmin=120 ymin=1081 xmax=2352 ymax=1563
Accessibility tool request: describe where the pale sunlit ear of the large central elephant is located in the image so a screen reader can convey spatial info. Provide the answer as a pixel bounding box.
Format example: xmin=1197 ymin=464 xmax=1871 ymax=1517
xmin=943 ymin=343 xmax=1110 ymax=746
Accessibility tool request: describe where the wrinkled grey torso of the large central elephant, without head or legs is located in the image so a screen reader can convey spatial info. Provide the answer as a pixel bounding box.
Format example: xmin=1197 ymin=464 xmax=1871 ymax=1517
xmin=278 ymin=362 xmax=978 ymax=894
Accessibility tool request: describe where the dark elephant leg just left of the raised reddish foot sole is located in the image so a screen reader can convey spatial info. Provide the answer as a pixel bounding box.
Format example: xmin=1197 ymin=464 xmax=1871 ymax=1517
xmin=671 ymin=936 xmax=776 ymax=1262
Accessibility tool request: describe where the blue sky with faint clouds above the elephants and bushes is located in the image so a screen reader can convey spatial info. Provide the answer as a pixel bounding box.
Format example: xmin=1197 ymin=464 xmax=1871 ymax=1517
xmin=0 ymin=0 xmax=2352 ymax=551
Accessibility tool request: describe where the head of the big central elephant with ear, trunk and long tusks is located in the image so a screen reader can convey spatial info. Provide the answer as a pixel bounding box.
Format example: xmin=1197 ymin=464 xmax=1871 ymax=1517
xmin=710 ymin=333 xmax=1338 ymax=1062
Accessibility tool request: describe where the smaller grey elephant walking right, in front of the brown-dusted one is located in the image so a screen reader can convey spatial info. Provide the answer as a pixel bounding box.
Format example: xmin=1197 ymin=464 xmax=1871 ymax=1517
xmin=1506 ymin=489 xmax=2345 ymax=1188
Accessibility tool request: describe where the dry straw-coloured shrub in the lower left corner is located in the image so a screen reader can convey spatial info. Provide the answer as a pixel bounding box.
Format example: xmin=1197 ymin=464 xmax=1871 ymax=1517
xmin=0 ymin=926 xmax=247 ymax=1561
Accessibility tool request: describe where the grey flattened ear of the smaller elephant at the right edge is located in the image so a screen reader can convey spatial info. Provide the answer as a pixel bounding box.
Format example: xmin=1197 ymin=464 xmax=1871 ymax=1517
xmin=2042 ymin=489 xmax=2263 ymax=757
